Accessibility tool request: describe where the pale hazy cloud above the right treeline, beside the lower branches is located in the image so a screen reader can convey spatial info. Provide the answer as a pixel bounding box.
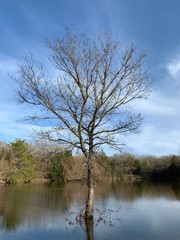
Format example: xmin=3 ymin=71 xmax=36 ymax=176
xmin=126 ymin=83 xmax=180 ymax=155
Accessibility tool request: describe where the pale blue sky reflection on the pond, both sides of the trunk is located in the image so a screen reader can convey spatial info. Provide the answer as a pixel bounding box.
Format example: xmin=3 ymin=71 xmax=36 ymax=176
xmin=0 ymin=183 xmax=180 ymax=240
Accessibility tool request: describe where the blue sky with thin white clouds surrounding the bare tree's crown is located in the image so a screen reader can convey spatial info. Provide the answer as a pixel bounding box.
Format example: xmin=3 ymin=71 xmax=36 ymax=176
xmin=0 ymin=0 xmax=180 ymax=156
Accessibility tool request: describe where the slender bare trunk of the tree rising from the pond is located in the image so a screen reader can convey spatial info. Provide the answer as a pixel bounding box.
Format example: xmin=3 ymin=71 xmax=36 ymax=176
xmin=85 ymin=157 xmax=94 ymax=219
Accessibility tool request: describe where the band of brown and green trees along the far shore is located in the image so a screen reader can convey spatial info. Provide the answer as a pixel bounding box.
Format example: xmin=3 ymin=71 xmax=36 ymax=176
xmin=0 ymin=139 xmax=180 ymax=184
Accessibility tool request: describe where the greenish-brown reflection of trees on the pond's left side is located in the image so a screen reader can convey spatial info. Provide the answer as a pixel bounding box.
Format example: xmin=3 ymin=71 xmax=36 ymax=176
xmin=0 ymin=184 xmax=71 ymax=231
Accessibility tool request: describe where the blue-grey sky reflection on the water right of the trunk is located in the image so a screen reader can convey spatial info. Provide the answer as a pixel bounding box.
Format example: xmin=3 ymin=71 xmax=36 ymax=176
xmin=95 ymin=198 xmax=180 ymax=240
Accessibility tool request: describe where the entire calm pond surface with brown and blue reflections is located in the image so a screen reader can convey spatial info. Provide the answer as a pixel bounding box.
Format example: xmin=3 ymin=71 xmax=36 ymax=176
xmin=0 ymin=181 xmax=180 ymax=240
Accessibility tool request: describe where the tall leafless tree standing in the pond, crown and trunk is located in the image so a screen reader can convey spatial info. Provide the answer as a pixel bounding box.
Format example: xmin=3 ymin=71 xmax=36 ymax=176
xmin=16 ymin=30 xmax=151 ymax=219
